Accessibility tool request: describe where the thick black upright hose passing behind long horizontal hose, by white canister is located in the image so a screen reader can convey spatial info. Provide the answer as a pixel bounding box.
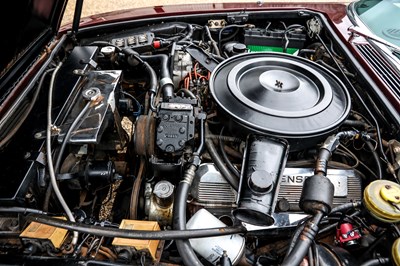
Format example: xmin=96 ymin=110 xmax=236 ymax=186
xmin=173 ymin=165 xmax=203 ymax=266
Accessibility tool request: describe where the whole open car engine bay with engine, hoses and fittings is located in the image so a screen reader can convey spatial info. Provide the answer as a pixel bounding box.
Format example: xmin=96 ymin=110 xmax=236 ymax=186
xmin=0 ymin=10 xmax=400 ymax=265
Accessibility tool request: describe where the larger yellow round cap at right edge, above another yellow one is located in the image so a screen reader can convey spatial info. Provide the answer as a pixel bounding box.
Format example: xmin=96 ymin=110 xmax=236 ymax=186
xmin=364 ymin=180 xmax=400 ymax=223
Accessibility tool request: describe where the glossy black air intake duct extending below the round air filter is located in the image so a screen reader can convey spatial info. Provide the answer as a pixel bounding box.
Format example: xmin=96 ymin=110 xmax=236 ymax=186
xmin=233 ymin=135 xmax=289 ymax=226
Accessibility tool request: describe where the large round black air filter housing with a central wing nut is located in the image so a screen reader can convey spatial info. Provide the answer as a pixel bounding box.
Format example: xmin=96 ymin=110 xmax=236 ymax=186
xmin=210 ymin=52 xmax=350 ymax=150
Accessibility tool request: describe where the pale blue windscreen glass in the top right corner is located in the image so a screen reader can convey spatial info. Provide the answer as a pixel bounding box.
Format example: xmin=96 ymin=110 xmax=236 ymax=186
xmin=355 ymin=0 xmax=400 ymax=46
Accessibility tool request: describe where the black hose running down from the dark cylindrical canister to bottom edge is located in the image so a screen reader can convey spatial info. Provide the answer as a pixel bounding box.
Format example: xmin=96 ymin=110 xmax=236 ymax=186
xmin=281 ymin=212 xmax=324 ymax=266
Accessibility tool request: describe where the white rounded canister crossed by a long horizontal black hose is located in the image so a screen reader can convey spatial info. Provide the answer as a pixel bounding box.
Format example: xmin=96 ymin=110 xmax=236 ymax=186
xmin=186 ymin=209 xmax=245 ymax=265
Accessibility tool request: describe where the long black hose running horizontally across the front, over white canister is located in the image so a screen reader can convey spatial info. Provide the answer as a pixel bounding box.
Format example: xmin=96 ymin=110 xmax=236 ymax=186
xmin=26 ymin=214 xmax=246 ymax=240
